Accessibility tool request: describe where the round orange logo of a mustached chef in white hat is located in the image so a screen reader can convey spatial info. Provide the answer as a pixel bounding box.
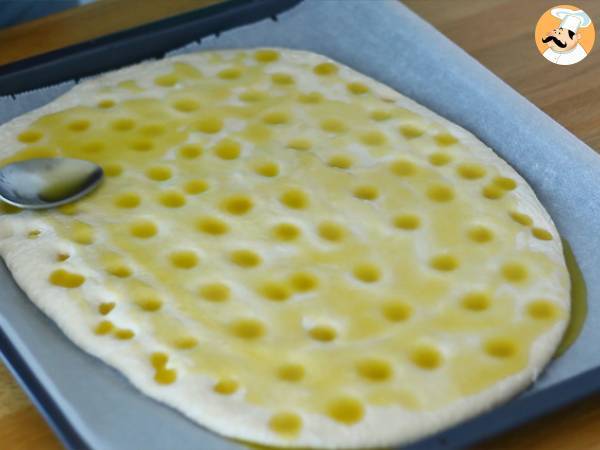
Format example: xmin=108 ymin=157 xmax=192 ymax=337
xmin=535 ymin=5 xmax=596 ymax=66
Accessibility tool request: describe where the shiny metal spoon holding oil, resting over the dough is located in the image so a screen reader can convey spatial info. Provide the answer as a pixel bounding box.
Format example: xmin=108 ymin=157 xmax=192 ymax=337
xmin=0 ymin=158 xmax=104 ymax=209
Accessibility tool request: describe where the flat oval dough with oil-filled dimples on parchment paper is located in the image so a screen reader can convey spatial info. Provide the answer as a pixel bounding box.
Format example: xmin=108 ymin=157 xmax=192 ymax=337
xmin=0 ymin=49 xmax=570 ymax=448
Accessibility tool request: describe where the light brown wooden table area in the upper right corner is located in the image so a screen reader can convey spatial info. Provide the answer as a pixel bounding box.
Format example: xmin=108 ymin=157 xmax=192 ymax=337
xmin=402 ymin=0 xmax=600 ymax=151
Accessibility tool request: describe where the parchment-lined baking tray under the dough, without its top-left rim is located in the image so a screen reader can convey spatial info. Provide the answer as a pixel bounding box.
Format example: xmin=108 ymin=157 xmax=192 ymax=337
xmin=0 ymin=0 xmax=600 ymax=450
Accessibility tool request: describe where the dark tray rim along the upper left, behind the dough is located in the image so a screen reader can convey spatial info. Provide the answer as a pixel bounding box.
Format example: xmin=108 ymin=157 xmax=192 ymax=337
xmin=0 ymin=0 xmax=302 ymax=96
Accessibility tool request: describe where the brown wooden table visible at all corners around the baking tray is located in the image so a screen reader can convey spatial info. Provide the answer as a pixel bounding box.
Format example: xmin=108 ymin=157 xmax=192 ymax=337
xmin=0 ymin=0 xmax=600 ymax=450
